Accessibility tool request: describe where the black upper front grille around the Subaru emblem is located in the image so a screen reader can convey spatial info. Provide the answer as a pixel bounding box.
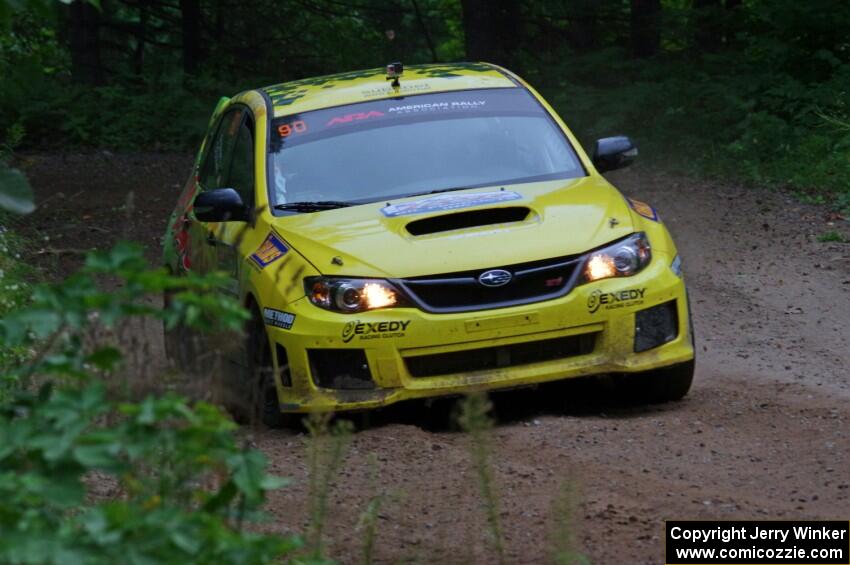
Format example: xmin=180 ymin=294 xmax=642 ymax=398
xmin=394 ymin=257 xmax=581 ymax=313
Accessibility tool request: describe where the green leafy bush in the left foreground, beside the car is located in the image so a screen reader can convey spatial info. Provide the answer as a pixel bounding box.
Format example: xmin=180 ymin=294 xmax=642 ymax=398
xmin=0 ymin=243 xmax=300 ymax=564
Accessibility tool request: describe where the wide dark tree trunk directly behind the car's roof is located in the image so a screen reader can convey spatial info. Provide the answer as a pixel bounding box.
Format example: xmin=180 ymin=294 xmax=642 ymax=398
xmin=461 ymin=0 xmax=521 ymax=65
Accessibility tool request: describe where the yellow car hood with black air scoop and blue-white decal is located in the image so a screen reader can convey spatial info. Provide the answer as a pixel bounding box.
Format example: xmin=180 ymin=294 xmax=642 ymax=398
xmin=273 ymin=177 xmax=634 ymax=278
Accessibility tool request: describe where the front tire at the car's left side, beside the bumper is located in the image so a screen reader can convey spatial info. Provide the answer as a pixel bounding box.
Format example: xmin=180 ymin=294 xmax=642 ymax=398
xmin=245 ymin=309 xmax=290 ymax=428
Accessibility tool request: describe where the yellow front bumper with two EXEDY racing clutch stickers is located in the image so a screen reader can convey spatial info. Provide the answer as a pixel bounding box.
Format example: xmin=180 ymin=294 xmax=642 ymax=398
xmin=266 ymin=254 xmax=694 ymax=412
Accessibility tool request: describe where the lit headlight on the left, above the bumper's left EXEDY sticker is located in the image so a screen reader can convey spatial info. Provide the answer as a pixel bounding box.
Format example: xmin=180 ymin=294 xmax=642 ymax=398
xmin=304 ymin=277 xmax=405 ymax=314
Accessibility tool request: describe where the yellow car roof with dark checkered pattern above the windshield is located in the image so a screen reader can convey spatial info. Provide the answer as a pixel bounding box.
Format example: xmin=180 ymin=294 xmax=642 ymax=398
xmin=259 ymin=63 xmax=519 ymax=117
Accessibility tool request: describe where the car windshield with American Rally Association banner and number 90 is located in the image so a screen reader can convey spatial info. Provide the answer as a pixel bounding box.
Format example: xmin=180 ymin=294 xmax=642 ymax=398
xmin=269 ymin=88 xmax=585 ymax=206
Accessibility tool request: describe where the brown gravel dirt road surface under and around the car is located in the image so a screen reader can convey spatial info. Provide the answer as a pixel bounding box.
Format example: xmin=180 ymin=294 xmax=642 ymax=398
xmin=21 ymin=153 xmax=850 ymax=563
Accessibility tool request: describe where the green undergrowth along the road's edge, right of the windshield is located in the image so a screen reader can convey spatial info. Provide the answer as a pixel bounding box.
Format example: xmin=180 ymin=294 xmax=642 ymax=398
xmin=529 ymin=48 xmax=850 ymax=215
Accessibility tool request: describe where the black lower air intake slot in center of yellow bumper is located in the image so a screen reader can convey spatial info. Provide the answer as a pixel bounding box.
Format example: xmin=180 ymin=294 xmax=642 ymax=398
xmin=404 ymin=333 xmax=597 ymax=377
